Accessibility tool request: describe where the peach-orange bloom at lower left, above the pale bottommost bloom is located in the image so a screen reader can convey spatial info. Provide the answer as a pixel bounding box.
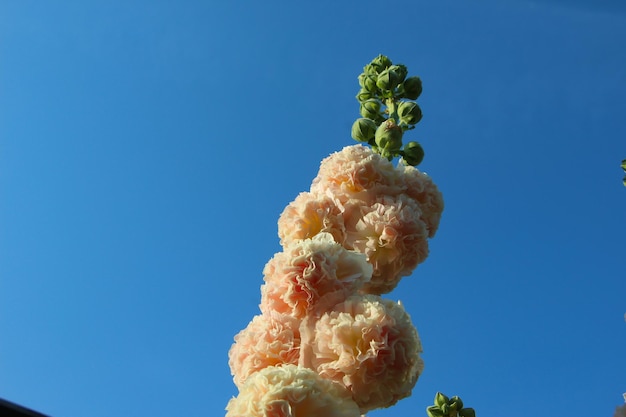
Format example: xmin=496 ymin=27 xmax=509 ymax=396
xmin=228 ymin=313 xmax=300 ymax=387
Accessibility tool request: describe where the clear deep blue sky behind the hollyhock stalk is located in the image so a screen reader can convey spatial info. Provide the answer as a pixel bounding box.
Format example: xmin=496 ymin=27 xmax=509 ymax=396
xmin=0 ymin=0 xmax=626 ymax=417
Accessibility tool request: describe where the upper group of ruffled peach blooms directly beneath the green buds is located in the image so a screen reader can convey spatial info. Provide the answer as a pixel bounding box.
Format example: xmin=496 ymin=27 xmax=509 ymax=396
xmin=278 ymin=145 xmax=443 ymax=295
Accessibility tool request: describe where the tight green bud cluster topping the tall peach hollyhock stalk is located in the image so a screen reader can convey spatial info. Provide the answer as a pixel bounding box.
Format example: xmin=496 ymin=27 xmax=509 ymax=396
xmin=352 ymin=55 xmax=424 ymax=166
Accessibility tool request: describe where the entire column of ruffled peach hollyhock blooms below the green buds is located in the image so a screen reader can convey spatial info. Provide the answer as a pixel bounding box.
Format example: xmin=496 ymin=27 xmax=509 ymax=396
xmin=227 ymin=141 xmax=443 ymax=417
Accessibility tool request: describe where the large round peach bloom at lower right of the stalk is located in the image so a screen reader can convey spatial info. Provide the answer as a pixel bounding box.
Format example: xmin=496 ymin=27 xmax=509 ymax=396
xmin=299 ymin=295 xmax=423 ymax=413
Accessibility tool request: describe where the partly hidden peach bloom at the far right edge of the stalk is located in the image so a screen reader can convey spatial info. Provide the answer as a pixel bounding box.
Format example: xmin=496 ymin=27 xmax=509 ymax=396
xmin=398 ymin=166 xmax=444 ymax=237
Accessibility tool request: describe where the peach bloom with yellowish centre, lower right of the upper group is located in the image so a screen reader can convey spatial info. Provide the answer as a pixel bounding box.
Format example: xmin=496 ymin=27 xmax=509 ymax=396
xmin=345 ymin=195 xmax=428 ymax=294
